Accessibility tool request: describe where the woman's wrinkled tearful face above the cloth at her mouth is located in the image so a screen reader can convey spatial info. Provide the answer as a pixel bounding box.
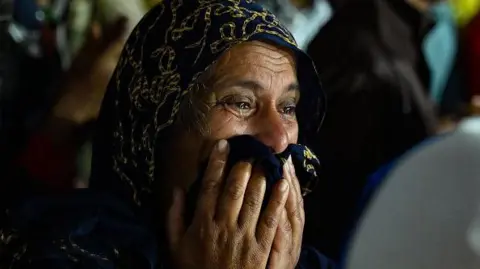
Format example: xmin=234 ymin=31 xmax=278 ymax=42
xmin=159 ymin=42 xmax=300 ymax=205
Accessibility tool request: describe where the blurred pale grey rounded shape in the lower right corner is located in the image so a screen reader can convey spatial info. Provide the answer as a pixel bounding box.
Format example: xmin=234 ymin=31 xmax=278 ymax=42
xmin=347 ymin=118 xmax=480 ymax=269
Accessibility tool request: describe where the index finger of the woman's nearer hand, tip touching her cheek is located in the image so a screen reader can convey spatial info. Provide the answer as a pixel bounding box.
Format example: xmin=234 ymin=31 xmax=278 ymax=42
xmin=194 ymin=140 xmax=228 ymax=221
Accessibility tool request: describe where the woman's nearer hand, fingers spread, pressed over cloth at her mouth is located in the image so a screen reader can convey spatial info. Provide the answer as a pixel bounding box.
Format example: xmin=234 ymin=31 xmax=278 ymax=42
xmin=167 ymin=140 xmax=290 ymax=269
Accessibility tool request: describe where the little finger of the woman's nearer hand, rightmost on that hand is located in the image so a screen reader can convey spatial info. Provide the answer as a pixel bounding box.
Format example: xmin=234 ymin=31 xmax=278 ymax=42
xmin=255 ymin=179 xmax=289 ymax=249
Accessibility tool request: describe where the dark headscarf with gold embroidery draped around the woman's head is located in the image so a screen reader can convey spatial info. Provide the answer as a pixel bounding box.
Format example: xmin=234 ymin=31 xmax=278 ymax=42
xmin=91 ymin=0 xmax=323 ymax=208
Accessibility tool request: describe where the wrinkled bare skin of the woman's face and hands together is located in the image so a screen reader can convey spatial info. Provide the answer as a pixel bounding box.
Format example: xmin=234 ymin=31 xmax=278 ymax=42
xmin=161 ymin=42 xmax=304 ymax=268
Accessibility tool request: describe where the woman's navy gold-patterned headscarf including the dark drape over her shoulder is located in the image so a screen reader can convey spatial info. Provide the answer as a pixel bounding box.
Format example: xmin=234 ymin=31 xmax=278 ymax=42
xmin=0 ymin=0 xmax=329 ymax=269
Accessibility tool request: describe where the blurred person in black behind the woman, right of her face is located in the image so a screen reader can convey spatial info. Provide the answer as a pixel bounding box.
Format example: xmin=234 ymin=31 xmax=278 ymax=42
xmin=306 ymin=0 xmax=438 ymax=258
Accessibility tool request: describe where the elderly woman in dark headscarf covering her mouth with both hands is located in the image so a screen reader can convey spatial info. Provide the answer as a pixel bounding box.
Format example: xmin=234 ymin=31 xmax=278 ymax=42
xmin=0 ymin=0 xmax=331 ymax=268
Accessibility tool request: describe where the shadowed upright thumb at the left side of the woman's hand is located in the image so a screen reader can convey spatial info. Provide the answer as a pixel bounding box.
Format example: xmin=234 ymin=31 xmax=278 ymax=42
xmin=167 ymin=188 xmax=185 ymax=249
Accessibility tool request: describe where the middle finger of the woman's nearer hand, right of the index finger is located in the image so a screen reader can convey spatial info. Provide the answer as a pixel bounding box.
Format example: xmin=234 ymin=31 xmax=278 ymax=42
xmin=215 ymin=162 xmax=252 ymax=224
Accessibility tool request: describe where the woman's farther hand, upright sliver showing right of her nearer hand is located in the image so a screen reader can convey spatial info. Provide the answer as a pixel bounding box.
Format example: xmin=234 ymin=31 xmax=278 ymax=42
xmin=268 ymin=158 xmax=305 ymax=269
